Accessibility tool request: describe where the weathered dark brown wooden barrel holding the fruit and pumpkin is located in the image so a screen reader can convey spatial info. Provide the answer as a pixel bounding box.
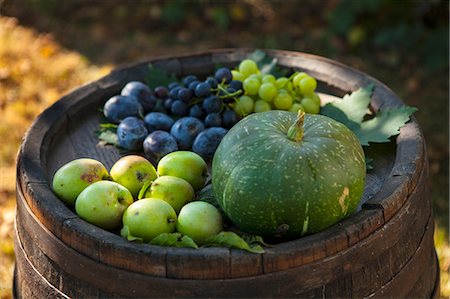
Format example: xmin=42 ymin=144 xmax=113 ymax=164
xmin=15 ymin=49 xmax=439 ymax=298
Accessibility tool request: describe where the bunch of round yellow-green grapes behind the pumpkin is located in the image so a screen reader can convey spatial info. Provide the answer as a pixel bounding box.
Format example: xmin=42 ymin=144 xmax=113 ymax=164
xmin=231 ymin=59 xmax=320 ymax=116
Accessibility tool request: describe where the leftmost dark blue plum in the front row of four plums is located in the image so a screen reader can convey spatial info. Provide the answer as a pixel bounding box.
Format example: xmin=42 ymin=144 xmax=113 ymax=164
xmin=117 ymin=116 xmax=148 ymax=151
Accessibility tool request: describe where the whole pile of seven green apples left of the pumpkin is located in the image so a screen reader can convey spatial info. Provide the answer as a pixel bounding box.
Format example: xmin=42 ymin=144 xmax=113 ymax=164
xmin=52 ymin=151 xmax=223 ymax=245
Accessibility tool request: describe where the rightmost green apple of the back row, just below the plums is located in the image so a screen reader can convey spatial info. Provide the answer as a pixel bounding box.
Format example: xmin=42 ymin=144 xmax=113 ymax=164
xmin=157 ymin=151 xmax=208 ymax=191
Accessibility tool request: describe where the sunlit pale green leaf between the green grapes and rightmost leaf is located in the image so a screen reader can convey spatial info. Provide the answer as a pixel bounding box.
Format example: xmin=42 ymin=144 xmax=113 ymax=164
xmin=321 ymin=84 xmax=374 ymax=129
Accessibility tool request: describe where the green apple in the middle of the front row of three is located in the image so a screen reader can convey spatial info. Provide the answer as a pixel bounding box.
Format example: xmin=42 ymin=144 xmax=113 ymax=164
xmin=120 ymin=198 xmax=177 ymax=242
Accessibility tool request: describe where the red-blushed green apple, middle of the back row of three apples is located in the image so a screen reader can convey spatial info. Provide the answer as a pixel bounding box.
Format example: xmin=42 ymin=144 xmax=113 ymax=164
xmin=110 ymin=155 xmax=157 ymax=198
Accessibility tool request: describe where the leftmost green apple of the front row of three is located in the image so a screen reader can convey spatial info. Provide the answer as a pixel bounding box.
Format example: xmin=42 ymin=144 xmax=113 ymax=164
xmin=75 ymin=181 xmax=133 ymax=230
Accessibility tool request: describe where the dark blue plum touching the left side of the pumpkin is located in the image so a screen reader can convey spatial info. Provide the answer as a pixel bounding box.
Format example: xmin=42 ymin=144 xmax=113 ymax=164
xmin=192 ymin=127 xmax=228 ymax=161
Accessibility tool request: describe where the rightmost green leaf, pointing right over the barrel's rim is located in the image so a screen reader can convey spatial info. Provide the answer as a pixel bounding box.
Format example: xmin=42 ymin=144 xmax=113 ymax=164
xmin=355 ymin=105 xmax=417 ymax=145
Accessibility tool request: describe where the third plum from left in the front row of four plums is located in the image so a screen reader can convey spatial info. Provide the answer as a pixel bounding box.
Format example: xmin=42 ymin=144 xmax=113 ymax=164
xmin=170 ymin=116 xmax=205 ymax=149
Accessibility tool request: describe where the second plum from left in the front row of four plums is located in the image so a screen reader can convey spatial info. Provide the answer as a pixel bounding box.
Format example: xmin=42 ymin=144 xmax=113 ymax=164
xmin=143 ymin=131 xmax=178 ymax=165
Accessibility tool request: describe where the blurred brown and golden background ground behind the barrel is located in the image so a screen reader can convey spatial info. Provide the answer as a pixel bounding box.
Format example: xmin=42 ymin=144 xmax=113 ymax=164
xmin=0 ymin=0 xmax=450 ymax=298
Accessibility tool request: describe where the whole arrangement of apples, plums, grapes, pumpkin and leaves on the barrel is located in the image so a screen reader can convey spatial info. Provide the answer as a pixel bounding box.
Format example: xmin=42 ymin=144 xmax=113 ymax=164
xmin=52 ymin=52 xmax=416 ymax=253
